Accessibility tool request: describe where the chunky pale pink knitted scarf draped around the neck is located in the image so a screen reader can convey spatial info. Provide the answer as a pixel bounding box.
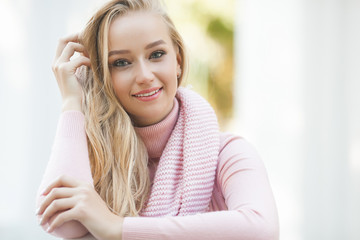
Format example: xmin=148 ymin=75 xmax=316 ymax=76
xmin=140 ymin=87 xmax=220 ymax=217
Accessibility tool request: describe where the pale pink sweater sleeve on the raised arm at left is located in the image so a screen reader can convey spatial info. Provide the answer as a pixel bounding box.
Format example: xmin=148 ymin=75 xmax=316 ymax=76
xmin=36 ymin=111 xmax=93 ymax=238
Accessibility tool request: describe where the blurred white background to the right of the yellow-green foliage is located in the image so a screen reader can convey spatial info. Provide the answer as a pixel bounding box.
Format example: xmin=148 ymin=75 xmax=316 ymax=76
xmin=234 ymin=0 xmax=360 ymax=240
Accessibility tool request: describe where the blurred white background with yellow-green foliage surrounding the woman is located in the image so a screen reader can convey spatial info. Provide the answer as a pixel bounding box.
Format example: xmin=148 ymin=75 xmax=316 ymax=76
xmin=0 ymin=0 xmax=360 ymax=240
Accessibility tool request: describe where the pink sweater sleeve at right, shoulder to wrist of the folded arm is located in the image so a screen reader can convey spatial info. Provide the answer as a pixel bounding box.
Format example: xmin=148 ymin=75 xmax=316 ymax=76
xmin=123 ymin=134 xmax=278 ymax=240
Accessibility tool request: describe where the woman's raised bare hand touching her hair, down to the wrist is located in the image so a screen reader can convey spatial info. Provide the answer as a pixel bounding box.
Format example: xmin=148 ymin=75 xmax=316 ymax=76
xmin=52 ymin=34 xmax=90 ymax=111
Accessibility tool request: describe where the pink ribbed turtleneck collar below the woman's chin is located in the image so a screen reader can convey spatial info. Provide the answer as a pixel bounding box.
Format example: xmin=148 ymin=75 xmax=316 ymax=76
xmin=135 ymin=98 xmax=179 ymax=159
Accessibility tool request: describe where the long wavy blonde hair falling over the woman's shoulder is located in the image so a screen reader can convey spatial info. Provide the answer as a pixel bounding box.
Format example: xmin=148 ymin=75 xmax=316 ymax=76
xmin=81 ymin=0 xmax=186 ymax=216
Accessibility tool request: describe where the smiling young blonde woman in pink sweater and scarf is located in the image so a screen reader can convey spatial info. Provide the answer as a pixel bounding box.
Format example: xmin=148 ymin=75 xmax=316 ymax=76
xmin=37 ymin=0 xmax=278 ymax=240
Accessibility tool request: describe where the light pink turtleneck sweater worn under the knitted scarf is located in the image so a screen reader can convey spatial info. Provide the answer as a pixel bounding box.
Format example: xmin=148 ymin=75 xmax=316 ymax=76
xmin=38 ymin=100 xmax=278 ymax=240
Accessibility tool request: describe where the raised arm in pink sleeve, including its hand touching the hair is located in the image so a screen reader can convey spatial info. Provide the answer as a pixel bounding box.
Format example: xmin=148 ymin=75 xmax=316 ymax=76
xmin=36 ymin=34 xmax=97 ymax=237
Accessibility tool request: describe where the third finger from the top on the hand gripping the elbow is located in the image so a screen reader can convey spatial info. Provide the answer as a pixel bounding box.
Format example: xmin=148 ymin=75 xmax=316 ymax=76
xmin=40 ymin=198 xmax=76 ymax=225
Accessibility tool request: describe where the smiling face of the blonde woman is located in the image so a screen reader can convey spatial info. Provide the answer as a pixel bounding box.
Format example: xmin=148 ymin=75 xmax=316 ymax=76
xmin=108 ymin=12 xmax=181 ymax=126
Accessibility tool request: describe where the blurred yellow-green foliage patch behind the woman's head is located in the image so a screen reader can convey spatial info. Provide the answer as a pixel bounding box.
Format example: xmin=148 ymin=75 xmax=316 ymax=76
xmin=165 ymin=0 xmax=235 ymax=129
